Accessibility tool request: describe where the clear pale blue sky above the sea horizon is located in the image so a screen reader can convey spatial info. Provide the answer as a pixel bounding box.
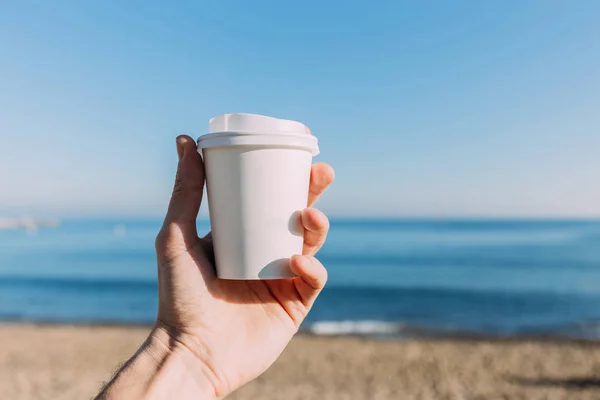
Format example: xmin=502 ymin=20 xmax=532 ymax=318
xmin=0 ymin=0 xmax=600 ymax=218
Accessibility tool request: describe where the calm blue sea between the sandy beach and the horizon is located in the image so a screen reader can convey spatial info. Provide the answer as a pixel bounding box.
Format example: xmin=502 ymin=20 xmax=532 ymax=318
xmin=0 ymin=219 xmax=600 ymax=339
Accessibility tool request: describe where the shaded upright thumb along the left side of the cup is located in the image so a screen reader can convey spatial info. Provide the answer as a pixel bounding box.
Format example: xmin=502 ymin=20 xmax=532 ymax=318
xmin=165 ymin=135 xmax=204 ymax=230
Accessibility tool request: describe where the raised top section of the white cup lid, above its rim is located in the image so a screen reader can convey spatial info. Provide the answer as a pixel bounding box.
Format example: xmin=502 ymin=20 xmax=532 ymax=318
xmin=208 ymin=114 xmax=310 ymax=134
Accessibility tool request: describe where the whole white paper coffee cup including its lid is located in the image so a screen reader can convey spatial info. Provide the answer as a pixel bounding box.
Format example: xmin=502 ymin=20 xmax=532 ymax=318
xmin=198 ymin=114 xmax=319 ymax=279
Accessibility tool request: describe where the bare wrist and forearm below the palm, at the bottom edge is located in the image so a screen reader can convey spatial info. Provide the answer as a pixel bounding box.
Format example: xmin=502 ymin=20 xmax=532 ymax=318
xmin=96 ymin=329 xmax=217 ymax=400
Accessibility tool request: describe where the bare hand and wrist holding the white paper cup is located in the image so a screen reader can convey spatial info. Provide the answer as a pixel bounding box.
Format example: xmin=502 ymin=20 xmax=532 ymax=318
xmin=97 ymin=136 xmax=334 ymax=400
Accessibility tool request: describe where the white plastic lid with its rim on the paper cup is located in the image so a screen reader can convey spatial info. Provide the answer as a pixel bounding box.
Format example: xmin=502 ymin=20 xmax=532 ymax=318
xmin=198 ymin=114 xmax=319 ymax=156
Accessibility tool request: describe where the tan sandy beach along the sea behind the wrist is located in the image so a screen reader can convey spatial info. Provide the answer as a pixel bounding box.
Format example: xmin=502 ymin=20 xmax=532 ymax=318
xmin=0 ymin=324 xmax=600 ymax=400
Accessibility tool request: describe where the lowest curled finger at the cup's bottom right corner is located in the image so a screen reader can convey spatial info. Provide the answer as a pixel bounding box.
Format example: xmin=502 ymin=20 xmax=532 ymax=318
xmin=290 ymin=255 xmax=327 ymax=308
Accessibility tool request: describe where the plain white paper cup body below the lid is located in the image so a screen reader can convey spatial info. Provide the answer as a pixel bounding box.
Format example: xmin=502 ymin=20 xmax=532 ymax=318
xmin=202 ymin=144 xmax=312 ymax=279
